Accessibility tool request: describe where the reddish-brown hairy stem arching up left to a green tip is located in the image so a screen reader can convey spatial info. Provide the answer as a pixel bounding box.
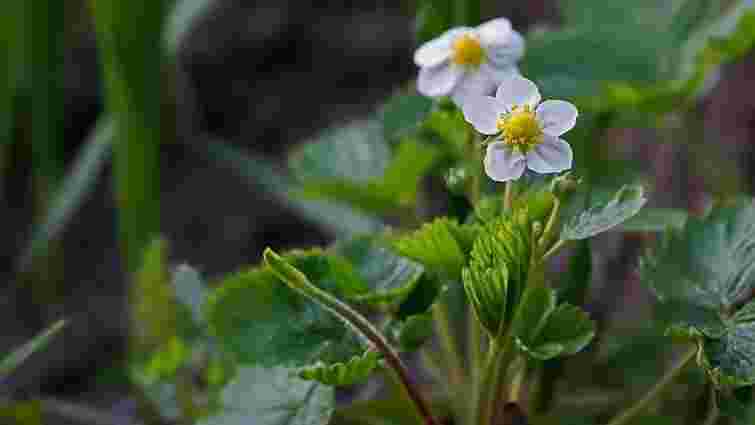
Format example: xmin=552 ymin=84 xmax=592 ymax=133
xmin=263 ymin=248 xmax=437 ymax=425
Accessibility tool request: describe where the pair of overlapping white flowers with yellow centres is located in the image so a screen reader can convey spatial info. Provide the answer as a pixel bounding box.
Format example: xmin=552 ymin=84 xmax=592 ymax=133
xmin=414 ymin=18 xmax=578 ymax=182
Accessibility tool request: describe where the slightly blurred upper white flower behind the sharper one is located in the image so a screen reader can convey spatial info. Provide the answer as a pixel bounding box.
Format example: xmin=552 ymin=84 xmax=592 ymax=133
xmin=414 ymin=18 xmax=524 ymax=105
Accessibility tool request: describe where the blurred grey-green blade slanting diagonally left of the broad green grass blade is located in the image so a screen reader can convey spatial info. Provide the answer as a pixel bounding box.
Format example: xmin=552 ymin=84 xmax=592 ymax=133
xmin=17 ymin=118 xmax=113 ymax=271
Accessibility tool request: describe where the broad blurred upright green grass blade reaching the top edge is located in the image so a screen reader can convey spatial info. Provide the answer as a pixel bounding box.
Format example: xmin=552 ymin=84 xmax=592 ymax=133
xmin=90 ymin=0 xmax=172 ymax=272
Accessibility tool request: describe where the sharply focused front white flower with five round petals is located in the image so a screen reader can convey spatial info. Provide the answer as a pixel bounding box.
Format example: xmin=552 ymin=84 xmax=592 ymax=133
xmin=462 ymin=76 xmax=577 ymax=182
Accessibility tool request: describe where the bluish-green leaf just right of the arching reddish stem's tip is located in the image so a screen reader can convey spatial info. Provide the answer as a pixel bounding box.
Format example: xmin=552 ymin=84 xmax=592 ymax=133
xmin=334 ymin=236 xmax=424 ymax=304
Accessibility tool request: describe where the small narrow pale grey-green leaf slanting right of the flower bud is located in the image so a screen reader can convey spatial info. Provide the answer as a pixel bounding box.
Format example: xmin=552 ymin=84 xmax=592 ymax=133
xmin=561 ymin=186 xmax=647 ymax=240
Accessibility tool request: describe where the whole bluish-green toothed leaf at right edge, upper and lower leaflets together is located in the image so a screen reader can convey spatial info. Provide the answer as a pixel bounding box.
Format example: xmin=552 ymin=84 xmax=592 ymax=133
xmin=642 ymin=199 xmax=755 ymax=386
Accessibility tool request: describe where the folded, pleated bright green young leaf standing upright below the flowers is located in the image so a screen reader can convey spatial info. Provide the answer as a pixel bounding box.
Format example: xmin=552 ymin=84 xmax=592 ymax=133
xmin=462 ymin=216 xmax=532 ymax=336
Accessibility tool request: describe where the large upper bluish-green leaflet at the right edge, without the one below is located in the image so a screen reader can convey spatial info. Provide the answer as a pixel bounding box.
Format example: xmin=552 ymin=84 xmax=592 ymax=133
xmin=641 ymin=199 xmax=755 ymax=337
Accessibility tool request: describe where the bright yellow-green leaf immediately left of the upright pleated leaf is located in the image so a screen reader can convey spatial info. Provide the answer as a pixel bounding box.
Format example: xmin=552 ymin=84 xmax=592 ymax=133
xmin=393 ymin=218 xmax=479 ymax=280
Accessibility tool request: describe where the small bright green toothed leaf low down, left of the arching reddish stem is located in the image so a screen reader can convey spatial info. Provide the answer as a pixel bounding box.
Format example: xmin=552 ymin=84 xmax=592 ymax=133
xmin=299 ymin=350 xmax=381 ymax=386
